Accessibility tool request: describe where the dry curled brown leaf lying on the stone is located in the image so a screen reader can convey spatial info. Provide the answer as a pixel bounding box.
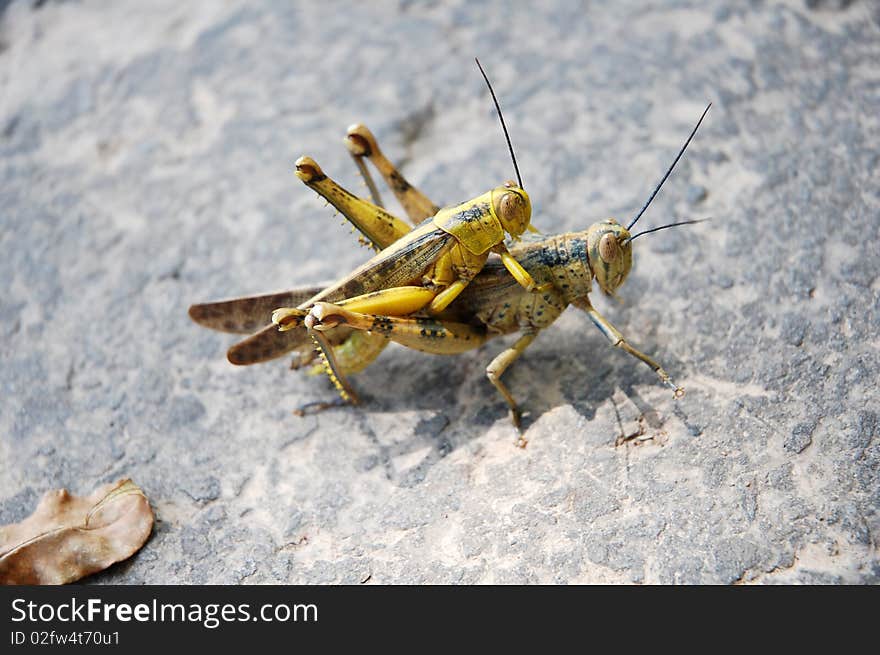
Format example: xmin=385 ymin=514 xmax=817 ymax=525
xmin=0 ymin=480 xmax=153 ymax=584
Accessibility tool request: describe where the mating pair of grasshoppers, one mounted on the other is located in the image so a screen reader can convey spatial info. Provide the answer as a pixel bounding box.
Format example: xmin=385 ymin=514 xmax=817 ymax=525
xmin=189 ymin=62 xmax=711 ymax=445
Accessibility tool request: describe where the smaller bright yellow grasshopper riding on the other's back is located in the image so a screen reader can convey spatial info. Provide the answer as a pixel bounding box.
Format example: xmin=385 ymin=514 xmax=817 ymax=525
xmin=272 ymin=61 xmax=535 ymax=348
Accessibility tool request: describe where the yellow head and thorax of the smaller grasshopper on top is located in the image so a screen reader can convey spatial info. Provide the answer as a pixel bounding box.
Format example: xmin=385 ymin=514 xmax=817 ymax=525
xmin=432 ymin=183 xmax=532 ymax=255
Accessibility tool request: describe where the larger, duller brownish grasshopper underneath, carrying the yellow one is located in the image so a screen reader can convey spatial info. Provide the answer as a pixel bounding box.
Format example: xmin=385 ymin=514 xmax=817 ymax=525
xmin=190 ymin=88 xmax=711 ymax=445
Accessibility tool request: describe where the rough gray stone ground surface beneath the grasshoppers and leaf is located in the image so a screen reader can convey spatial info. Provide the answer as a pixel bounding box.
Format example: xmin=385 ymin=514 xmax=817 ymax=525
xmin=0 ymin=0 xmax=880 ymax=583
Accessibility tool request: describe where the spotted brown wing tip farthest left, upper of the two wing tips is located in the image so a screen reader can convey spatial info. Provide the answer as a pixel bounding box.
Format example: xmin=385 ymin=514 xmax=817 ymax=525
xmin=189 ymin=285 xmax=326 ymax=334
